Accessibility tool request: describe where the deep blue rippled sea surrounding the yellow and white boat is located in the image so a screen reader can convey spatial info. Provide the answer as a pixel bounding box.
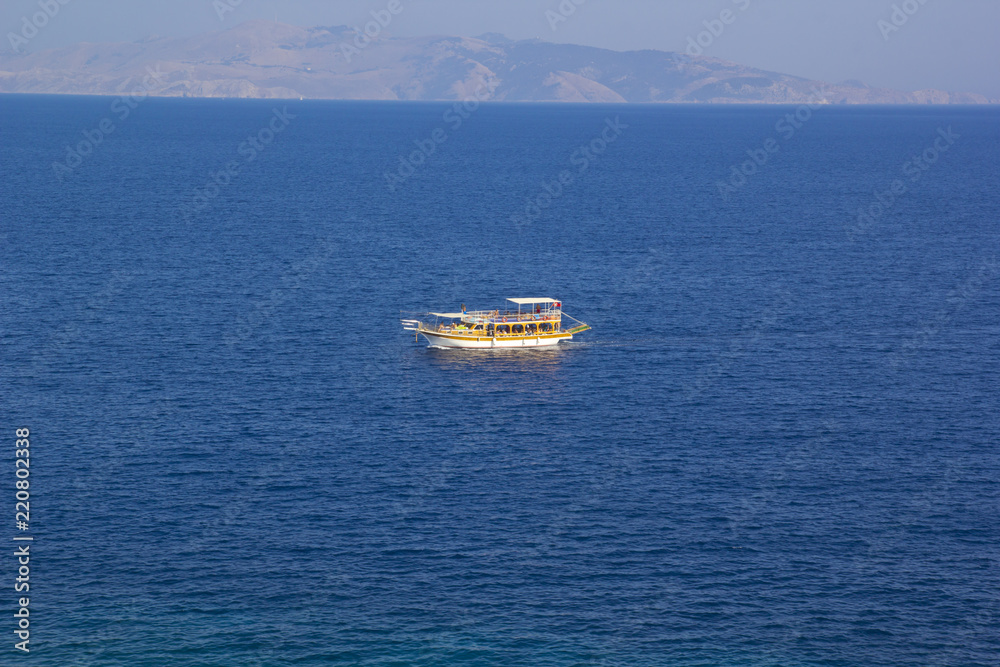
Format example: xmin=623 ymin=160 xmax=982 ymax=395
xmin=0 ymin=96 xmax=1000 ymax=667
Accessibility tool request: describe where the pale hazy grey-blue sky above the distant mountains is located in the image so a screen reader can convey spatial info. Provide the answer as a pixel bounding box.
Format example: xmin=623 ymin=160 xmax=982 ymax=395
xmin=7 ymin=0 xmax=1000 ymax=98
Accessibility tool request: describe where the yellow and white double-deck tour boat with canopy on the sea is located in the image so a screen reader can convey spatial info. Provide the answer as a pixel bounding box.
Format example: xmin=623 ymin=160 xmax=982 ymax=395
xmin=400 ymin=298 xmax=590 ymax=350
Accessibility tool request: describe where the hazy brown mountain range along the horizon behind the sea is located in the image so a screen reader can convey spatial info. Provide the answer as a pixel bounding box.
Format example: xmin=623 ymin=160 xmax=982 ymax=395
xmin=0 ymin=21 xmax=998 ymax=104
